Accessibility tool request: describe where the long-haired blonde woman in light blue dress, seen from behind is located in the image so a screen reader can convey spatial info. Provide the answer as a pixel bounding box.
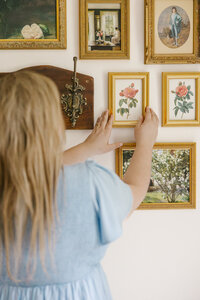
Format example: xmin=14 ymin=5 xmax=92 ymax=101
xmin=0 ymin=71 xmax=158 ymax=300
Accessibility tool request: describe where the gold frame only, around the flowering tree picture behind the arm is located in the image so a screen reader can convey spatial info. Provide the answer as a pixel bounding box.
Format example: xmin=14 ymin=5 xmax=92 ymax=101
xmin=115 ymin=143 xmax=196 ymax=209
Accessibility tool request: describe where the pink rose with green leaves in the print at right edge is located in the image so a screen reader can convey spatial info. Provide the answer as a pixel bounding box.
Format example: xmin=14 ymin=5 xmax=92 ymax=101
xmin=171 ymin=81 xmax=194 ymax=118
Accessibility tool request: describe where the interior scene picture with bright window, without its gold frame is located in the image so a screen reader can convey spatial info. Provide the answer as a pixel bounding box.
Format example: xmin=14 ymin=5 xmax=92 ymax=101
xmin=87 ymin=1 xmax=122 ymax=52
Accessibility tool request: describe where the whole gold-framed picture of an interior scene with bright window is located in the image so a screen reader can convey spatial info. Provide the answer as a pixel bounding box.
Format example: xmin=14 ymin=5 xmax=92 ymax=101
xmin=79 ymin=0 xmax=130 ymax=59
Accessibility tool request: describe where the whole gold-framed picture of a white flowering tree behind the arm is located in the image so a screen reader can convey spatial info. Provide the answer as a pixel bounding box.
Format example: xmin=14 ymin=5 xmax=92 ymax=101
xmin=116 ymin=143 xmax=196 ymax=209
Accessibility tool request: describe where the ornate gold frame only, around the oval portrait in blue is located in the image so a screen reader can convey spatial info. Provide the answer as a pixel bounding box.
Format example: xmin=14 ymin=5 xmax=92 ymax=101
xmin=144 ymin=0 xmax=199 ymax=64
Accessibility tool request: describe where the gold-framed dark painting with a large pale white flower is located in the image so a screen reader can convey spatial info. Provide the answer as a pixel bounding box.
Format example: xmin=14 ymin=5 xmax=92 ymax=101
xmin=0 ymin=0 xmax=67 ymax=49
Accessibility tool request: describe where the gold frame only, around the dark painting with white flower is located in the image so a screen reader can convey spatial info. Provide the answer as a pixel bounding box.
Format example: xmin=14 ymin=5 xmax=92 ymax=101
xmin=0 ymin=0 xmax=67 ymax=50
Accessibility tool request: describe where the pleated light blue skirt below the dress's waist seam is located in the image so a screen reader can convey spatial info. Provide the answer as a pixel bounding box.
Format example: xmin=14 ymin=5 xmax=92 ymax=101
xmin=0 ymin=266 xmax=112 ymax=300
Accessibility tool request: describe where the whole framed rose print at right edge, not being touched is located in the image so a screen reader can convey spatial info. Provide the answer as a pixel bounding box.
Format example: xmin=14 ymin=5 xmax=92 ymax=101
xmin=162 ymin=73 xmax=200 ymax=126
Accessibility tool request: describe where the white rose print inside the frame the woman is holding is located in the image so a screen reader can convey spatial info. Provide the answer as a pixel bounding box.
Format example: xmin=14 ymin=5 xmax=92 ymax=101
xmin=114 ymin=79 xmax=143 ymax=121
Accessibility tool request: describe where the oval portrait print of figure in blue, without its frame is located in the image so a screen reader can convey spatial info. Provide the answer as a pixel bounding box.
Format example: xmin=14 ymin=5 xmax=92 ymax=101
xmin=154 ymin=0 xmax=194 ymax=55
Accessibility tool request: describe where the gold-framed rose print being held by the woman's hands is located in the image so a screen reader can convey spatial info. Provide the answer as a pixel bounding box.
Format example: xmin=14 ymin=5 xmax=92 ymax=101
xmin=108 ymin=72 xmax=149 ymax=127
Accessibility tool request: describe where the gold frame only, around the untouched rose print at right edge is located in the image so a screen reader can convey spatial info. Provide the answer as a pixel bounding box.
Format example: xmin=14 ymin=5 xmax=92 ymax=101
xmin=162 ymin=72 xmax=200 ymax=127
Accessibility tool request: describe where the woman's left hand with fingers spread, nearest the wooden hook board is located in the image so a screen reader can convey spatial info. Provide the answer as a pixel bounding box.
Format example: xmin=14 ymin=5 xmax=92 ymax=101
xmin=84 ymin=110 xmax=122 ymax=156
